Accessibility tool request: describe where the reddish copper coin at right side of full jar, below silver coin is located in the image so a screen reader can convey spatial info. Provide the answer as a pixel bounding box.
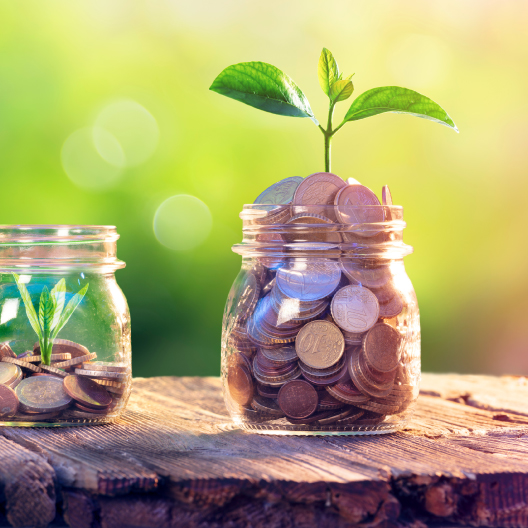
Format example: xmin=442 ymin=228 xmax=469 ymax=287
xmin=363 ymin=323 xmax=401 ymax=372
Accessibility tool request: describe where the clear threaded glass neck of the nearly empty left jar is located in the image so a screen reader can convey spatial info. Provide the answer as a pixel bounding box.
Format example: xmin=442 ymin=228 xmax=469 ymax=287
xmin=0 ymin=225 xmax=125 ymax=273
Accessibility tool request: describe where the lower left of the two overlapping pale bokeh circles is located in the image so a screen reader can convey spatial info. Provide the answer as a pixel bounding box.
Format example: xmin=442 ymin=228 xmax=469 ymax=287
xmin=61 ymin=127 xmax=122 ymax=190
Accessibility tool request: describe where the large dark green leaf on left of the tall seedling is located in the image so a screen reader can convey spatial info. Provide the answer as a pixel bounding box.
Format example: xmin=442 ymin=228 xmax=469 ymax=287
xmin=209 ymin=62 xmax=319 ymax=125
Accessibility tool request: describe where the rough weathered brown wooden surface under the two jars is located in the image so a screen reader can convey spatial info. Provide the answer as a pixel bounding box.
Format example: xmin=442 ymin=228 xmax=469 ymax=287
xmin=0 ymin=374 xmax=528 ymax=528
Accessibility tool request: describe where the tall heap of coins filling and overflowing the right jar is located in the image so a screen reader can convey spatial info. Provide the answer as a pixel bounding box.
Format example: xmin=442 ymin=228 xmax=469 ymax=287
xmin=224 ymin=173 xmax=417 ymax=427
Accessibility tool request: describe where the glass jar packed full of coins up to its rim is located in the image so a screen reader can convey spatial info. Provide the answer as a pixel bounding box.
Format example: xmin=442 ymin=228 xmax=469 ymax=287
xmin=222 ymin=204 xmax=420 ymax=435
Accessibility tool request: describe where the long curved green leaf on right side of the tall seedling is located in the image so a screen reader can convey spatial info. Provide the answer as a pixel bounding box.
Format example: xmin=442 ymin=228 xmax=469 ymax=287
xmin=343 ymin=86 xmax=458 ymax=132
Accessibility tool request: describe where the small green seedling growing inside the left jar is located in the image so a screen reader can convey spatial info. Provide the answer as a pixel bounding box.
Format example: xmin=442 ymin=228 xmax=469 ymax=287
xmin=13 ymin=273 xmax=88 ymax=365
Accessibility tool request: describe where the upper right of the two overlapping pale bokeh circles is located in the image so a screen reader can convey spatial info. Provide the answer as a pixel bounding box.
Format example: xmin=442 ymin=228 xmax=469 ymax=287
xmin=94 ymin=100 xmax=159 ymax=167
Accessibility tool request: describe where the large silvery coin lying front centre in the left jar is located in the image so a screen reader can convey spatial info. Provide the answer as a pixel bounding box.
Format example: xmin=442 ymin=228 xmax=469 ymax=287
xmin=15 ymin=376 xmax=72 ymax=413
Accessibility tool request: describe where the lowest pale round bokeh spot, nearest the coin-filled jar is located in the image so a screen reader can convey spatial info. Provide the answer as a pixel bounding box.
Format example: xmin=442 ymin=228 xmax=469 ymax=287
xmin=154 ymin=194 xmax=213 ymax=251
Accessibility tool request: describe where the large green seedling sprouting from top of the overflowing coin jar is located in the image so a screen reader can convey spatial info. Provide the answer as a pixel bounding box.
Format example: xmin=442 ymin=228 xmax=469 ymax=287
xmin=209 ymin=48 xmax=458 ymax=172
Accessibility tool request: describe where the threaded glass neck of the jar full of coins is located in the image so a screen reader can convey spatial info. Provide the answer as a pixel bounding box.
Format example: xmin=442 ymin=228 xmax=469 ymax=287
xmin=233 ymin=204 xmax=413 ymax=260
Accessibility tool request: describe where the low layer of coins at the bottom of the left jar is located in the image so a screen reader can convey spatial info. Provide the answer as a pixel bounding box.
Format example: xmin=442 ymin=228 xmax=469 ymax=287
xmin=0 ymin=339 xmax=131 ymax=422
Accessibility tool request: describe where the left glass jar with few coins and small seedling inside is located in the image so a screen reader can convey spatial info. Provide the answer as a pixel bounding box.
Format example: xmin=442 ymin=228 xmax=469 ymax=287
xmin=0 ymin=225 xmax=132 ymax=427
